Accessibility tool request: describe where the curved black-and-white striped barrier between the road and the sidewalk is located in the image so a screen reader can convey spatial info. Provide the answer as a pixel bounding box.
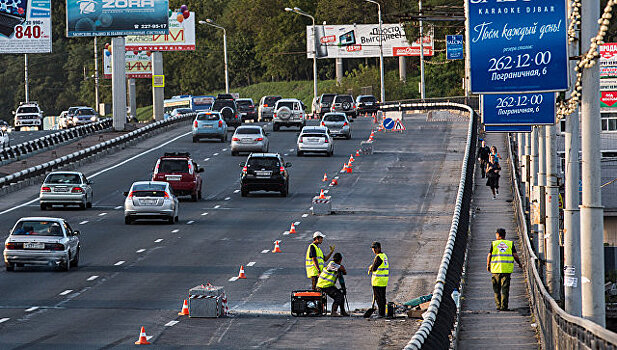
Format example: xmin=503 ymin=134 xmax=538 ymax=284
xmin=381 ymin=99 xmax=478 ymax=350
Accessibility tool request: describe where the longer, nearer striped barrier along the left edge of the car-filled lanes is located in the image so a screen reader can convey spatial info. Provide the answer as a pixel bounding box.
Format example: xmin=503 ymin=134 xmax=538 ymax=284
xmin=0 ymin=113 xmax=196 ymax=188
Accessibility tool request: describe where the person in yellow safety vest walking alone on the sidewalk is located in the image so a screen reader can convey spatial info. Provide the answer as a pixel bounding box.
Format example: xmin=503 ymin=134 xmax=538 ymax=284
xmin=486 ymin=228 xmax=523 ymax=311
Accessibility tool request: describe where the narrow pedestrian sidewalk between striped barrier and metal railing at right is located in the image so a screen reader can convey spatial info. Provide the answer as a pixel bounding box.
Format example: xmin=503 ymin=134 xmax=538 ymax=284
xmin=458 ymin=134 xmax=540 ymax=350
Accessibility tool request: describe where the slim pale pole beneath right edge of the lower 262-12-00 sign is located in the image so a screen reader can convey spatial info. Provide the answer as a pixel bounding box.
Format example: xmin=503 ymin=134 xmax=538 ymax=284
xmin=545 ymin=124 xmax=561 ymax=300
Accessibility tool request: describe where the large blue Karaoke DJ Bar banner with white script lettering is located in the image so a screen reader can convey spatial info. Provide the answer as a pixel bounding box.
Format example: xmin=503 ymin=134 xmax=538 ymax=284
xmin=466 ymin=0 xmax=568 ymax=94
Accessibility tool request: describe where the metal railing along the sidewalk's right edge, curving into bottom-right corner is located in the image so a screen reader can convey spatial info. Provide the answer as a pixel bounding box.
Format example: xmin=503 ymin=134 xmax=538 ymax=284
xmin=508 ymin=136 xmax=617 ymax=350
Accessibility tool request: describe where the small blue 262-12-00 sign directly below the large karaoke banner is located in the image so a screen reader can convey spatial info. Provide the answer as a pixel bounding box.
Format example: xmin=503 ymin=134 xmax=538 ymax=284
xmin=482 ymin=92 xmax=555 ymax=125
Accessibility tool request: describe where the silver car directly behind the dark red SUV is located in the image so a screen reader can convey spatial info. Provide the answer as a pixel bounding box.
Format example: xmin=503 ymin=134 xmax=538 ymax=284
xmin=124 ymin=181 xmax=178 ymax=225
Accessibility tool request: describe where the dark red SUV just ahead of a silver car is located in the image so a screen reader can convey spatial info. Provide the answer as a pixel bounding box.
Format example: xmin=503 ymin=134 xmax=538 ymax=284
xmin=152 ymin=152 xmax=204 ymax=202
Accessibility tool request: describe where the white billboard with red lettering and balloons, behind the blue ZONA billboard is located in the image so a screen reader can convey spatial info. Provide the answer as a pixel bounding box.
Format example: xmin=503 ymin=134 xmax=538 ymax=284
xmin=126 ymin=12 xmax=195 ymax=51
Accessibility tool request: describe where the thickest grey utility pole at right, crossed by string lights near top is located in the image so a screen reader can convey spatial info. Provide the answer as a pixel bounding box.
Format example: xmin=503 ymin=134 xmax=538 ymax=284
xmin=581 ymin=0 xmax=606 ymax=327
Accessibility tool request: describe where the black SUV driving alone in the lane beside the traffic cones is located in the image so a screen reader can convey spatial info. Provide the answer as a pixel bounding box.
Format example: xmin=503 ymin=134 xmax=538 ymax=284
xmin=240 ymin=153 xmax=291 ymax=197
